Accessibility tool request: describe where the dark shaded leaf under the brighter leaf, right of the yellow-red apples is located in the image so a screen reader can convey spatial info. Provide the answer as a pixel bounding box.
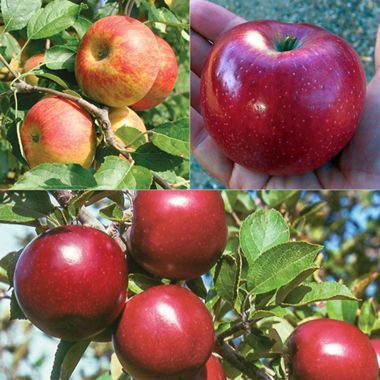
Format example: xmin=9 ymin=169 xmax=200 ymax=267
xmin=132 ymin=143 xmax=182 ymax=172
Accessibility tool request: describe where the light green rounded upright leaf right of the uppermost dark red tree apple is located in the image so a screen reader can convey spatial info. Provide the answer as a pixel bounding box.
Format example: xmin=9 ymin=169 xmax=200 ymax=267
xmin=240 ymin=210 xmax=290 ymax=265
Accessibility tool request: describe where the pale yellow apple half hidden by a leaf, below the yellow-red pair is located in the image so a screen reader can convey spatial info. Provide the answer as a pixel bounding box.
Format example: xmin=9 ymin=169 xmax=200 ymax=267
xmin=109 ymin=107 xmax=148 ymax=153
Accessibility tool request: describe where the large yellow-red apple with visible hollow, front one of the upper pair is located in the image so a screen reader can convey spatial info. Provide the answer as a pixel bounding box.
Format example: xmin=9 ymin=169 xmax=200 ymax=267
xmin=75 ymin=16 xmax=160 ymax=107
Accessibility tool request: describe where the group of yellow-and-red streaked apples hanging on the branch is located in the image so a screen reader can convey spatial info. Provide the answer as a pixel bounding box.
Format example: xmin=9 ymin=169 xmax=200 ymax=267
xmin=20 ymin=16 xmax=178 ymax=167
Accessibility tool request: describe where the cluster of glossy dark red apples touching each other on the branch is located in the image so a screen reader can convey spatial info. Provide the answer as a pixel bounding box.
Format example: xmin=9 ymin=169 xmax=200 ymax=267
xmin=14 ymin=191 xmax=227 ymax=380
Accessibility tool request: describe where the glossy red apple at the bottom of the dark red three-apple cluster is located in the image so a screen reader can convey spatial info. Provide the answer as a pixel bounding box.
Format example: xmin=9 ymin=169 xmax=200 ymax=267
xmin=112 ymin=285 xmax=214 ymax=380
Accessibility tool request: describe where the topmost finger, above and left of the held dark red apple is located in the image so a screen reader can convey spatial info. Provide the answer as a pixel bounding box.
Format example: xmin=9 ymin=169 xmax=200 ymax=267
xmin=190 ymin=0 xmax=245 ymax=41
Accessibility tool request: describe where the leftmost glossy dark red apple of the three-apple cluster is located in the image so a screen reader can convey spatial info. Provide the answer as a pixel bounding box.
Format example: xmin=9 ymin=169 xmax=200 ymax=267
xmin=14 ymin=226 xmax=128 ymax=341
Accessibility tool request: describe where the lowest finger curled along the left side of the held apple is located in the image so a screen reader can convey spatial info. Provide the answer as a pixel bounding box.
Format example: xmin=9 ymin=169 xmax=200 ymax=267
xmin=191 ymin=108 xmax=233 ymax=186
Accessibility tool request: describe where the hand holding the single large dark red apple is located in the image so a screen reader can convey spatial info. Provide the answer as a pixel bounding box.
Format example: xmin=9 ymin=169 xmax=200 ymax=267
xmin=190 ymin=0 xmax=380 ymax=189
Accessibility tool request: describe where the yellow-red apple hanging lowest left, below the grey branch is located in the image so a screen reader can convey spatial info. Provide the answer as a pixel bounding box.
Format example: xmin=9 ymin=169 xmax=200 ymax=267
xmin=20 ymin=96 xmax=96 ymax=168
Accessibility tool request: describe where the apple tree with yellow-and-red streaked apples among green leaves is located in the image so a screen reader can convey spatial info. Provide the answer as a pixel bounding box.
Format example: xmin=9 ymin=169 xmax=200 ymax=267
xmin=0 ymin=0 xmax=189 ymax=190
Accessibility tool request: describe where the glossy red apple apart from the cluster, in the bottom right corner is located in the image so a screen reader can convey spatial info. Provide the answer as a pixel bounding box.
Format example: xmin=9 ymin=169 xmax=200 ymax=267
xmin=288 ymin=319 xmax=378 ymax=380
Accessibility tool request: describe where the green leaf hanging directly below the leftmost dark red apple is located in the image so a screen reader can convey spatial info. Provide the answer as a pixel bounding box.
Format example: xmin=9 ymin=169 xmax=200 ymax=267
xmin=50 ymin=340 xmax=91 ymax=380
